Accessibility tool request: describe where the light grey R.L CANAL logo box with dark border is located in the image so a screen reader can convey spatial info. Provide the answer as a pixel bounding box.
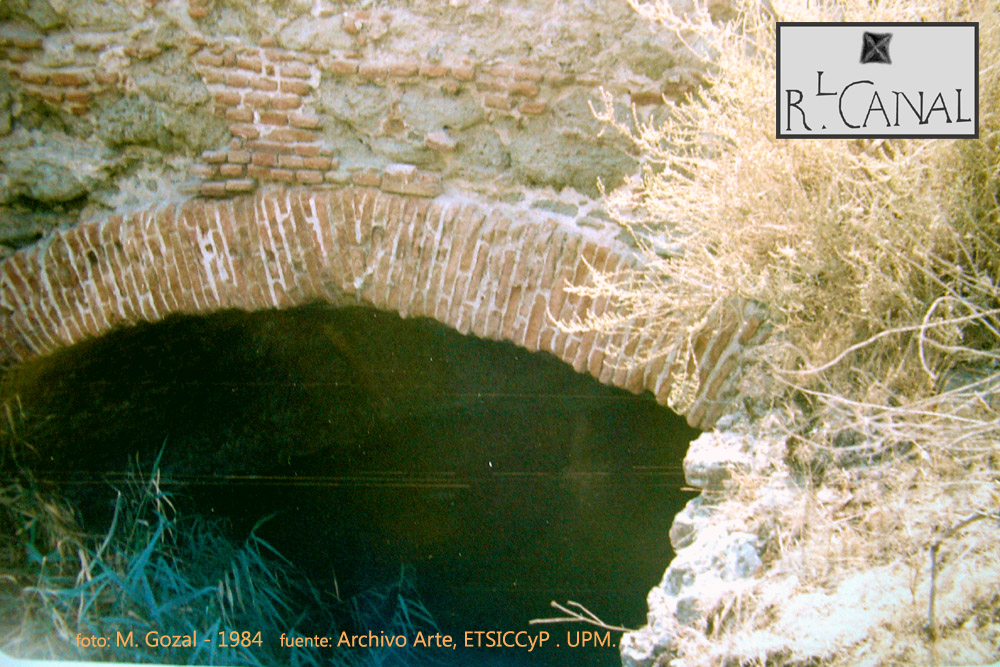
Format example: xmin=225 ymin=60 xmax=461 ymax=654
xmin=776 ymin=22 xmax=979 ymax=139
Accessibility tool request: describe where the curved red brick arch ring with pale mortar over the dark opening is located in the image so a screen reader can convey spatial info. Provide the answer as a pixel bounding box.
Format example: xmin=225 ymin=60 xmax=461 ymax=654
xmin=0 ymin=188 xmax=760 ymax=427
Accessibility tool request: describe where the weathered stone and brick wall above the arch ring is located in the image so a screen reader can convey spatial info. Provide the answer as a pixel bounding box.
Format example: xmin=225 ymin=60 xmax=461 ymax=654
xmin=0 ymin=0 xmax=697 ymax=247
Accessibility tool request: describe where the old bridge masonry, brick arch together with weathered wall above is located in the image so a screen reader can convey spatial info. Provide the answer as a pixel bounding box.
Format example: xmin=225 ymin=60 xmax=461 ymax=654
xmin=0 ymin=0 xmax=760 ymax=427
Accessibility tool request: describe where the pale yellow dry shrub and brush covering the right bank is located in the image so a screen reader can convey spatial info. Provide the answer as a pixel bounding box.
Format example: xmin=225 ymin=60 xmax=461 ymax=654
xmin=575 ymin=0 xmax=1000 ymax=664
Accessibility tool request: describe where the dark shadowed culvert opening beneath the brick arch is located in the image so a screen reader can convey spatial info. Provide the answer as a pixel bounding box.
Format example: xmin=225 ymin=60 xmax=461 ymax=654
xmin=5 ymin=307 xmax=696 ymax=665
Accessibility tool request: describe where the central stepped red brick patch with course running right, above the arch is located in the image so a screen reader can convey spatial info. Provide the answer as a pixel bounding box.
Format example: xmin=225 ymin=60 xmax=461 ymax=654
xmin=182 ymin=34 xmax=572 ymax=197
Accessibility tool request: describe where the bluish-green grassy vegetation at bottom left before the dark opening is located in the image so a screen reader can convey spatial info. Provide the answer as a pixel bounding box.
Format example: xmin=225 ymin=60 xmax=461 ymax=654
xmin=0 ymin=453 xmax=435 ymax=667
